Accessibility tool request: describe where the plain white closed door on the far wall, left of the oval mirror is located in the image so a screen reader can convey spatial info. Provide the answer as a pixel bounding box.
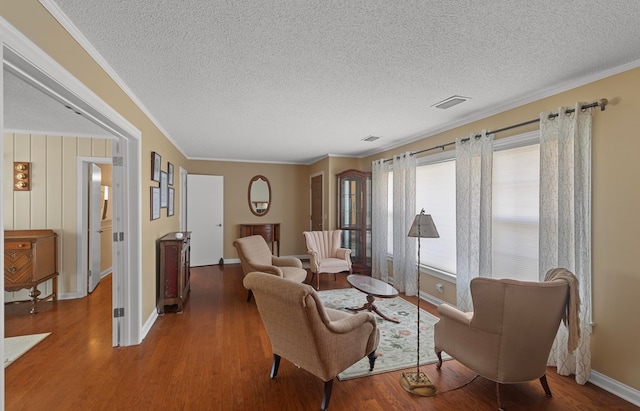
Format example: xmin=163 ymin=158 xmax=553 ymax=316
xmin=187 ymin=174 xmax=224 ymax=266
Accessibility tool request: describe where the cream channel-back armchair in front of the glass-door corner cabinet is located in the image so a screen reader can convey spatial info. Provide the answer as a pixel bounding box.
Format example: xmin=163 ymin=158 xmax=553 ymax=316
xmin=303 ymin=230 xmax=351 ymax=290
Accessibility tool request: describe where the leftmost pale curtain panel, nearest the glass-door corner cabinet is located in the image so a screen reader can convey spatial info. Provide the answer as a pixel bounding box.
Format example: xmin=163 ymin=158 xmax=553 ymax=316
xmin=371 ymin=160 xmax=390 ymax=282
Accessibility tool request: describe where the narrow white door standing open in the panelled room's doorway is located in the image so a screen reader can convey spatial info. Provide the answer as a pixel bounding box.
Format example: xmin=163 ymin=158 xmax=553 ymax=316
xmin=87 ymin=163 xmax=102 ymax=293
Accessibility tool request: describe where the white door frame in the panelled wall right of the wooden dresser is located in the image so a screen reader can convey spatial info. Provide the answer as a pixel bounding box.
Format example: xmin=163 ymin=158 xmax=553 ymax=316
xmin=77 ymin=157 xmax=115 ymax=298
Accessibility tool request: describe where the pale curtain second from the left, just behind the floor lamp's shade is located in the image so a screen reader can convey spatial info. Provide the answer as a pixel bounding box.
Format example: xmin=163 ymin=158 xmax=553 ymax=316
xmin=393 ymin=152 xmax=418 ymax=296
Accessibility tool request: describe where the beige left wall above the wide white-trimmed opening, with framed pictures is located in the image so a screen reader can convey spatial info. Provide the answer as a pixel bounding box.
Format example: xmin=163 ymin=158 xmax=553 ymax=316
xmin=0 ymin=0 xmax=186 ymax=330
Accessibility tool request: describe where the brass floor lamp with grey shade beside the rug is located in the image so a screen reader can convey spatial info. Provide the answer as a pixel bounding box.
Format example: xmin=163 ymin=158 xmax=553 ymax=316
xmin=400 ymin=208 xmax=440 ymax=397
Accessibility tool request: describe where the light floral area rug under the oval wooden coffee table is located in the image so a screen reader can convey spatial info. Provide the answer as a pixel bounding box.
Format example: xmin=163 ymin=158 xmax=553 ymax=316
xmin=318 ymin=288 xmax=450 ymax=380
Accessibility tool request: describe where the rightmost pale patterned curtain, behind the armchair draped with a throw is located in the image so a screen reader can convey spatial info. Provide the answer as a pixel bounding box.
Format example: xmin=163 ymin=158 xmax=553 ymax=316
xmin=539 ymin=103 xmax=591 ymax=384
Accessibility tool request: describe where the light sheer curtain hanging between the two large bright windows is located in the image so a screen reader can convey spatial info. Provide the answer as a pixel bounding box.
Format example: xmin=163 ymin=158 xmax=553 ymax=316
xmin=456 ymin=130 xmax=493 ymax=311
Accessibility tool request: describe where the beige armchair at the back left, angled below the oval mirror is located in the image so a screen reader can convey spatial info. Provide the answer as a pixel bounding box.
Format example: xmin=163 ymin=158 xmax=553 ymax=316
xmin=233 ymin=235 xmax=307 ymax=301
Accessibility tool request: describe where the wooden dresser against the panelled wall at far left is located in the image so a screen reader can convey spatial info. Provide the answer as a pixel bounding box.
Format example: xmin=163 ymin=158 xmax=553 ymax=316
xmin=4 ymin=230 xmax=58 ymax=313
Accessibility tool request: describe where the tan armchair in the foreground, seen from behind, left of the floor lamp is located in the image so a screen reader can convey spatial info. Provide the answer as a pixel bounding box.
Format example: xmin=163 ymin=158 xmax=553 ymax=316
xmin=243 ymin=272 xmax=380 ymax=410
